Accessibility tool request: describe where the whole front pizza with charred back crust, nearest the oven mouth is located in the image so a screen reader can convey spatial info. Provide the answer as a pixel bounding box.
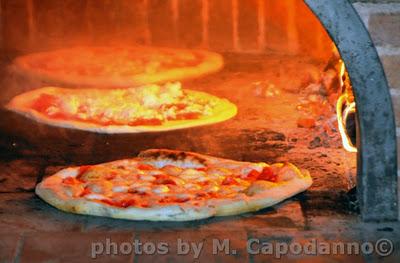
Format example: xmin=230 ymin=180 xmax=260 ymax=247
xmin=36 ymin=149 xmax=312 ymax=221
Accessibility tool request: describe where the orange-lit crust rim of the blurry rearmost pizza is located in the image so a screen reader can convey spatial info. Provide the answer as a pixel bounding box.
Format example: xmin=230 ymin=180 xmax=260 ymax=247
xmin=13 ymin=46 xmax=224 ymax=88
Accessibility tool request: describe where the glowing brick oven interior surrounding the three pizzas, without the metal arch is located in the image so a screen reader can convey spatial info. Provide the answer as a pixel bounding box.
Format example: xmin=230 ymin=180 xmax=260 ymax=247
xmin=0 ymin=0 xmax=399 ymax=262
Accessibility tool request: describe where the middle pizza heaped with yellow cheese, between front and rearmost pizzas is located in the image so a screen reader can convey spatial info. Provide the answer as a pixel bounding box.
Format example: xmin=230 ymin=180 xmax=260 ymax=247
xmin=6 ymin=83 xmax=237 ymax=133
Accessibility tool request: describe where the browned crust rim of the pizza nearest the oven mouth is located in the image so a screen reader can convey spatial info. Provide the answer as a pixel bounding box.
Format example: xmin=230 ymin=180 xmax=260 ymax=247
xmin=36 ymin=149 xmax=312 ymax=221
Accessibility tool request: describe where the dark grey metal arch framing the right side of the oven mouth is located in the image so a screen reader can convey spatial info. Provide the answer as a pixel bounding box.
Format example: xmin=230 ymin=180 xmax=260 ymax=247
xmin=304 ymin=0 xmax=399 ymax=221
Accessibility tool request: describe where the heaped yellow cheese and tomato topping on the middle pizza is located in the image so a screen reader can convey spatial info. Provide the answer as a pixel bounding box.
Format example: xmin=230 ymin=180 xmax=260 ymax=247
xmin=31 ymin=83 xmax=219 ymax=126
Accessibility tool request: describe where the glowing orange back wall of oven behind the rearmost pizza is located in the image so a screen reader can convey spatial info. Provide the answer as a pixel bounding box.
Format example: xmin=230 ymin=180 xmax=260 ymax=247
xmin=0 ymin=0 xmax=331 ymax=62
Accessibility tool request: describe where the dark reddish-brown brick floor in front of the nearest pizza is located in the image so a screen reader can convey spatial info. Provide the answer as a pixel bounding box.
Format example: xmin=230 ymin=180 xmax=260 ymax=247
xmin=0 ymin=192 xmax=400 ymax=262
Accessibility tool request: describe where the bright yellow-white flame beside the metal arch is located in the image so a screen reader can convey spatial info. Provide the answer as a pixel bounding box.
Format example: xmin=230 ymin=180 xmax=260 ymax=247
xmin=336 ymin=60 xmax=357 ymax=152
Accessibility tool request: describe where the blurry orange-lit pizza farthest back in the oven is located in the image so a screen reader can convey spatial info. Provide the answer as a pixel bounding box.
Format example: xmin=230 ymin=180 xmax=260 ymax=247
xmin=13 ymin=46 xmax=223 ymax=87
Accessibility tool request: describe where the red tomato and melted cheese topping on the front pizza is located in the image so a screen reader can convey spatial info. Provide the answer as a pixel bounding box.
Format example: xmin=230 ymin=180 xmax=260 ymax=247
xmin=62 ymin=159 xmax=277 ymax=207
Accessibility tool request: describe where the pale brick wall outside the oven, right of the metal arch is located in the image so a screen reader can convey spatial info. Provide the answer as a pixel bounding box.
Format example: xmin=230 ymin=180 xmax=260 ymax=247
xmin=354 ymin=0 xmax=400 ymax=176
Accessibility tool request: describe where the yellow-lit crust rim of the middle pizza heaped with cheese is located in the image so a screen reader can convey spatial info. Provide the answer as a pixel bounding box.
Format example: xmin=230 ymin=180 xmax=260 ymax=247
xmin=5 ymin=87 xmax=237 ymax=134
